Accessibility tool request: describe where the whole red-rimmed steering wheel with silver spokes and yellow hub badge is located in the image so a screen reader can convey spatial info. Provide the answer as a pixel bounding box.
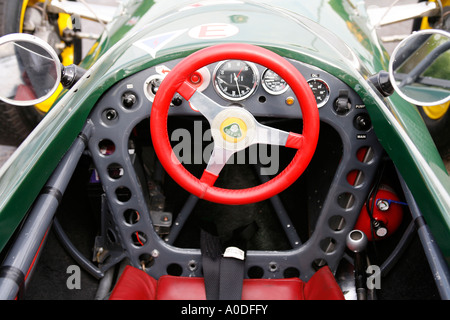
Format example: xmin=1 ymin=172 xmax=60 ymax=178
xmin=150 ymin=44 xmax=320 ymax=205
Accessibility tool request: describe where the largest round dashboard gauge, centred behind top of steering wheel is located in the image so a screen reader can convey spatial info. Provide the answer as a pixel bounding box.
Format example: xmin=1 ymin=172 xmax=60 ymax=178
xmin=214 ymin=60 xmax=258 ymax=101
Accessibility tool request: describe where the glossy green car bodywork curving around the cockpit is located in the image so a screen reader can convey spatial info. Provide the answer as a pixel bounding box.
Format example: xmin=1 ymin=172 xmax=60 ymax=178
xmin=0 ymin=0 xmax=450 ymax=259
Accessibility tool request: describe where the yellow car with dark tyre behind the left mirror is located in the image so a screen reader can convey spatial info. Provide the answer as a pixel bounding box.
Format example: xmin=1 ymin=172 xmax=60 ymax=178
xmin=0 ymin=0 xmax=81 ymax=146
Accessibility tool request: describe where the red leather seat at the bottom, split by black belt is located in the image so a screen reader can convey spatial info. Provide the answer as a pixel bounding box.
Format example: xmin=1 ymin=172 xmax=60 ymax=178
xmin=110 ymin=266 xmax=344 ymax=300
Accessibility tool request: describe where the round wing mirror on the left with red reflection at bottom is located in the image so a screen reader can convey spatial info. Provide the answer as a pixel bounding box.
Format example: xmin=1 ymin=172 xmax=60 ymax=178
xmin=0 ymin=33 xmax=61 ymax=106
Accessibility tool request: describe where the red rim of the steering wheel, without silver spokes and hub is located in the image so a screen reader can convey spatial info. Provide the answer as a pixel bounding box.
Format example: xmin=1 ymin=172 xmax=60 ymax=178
xmin=150 ymin=43 xmax=320 ymax=205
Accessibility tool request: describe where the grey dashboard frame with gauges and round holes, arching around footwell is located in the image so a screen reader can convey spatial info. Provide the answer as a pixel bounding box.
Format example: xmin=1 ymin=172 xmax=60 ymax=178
xmin=89 ymin=56 xmax=383 ymax=276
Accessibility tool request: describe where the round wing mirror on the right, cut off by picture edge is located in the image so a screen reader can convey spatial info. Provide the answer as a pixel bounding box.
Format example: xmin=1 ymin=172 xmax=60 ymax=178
xmin=389 ymin=30 xmax=450 ymax=106
